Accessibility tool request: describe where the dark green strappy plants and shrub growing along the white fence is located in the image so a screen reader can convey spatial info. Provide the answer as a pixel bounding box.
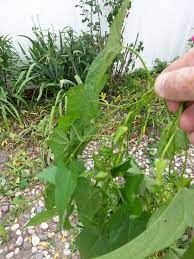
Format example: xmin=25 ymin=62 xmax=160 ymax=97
xmin=0 ymin=0 xmax=143 ymax=131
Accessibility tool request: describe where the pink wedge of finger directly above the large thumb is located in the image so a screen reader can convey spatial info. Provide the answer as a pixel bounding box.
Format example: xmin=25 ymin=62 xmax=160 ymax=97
xmin=163 ymin=48 xmax=194 ymax=73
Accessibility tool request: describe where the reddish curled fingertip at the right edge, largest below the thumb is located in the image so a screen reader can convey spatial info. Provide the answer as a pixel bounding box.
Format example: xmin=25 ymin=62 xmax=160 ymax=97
xmin=180 ymin=104 xmax=194 ymax=132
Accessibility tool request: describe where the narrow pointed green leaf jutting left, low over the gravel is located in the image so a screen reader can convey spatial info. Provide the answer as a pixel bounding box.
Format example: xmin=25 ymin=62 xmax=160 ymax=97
xmin=26 ymin=209 xmax=57 ymax=227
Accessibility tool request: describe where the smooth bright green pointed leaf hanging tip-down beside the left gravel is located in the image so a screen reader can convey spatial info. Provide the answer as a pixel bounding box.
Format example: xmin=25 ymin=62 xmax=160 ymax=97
xmin=55 ymin=161 xmax=83 ymax=224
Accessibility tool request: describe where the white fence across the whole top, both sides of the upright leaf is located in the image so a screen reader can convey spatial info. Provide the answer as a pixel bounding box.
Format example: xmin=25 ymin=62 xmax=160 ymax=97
xmin=0 ymin=0 xmax=194 ymax=66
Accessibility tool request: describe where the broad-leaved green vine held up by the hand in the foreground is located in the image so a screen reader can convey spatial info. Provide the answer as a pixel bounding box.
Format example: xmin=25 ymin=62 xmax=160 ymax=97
xmin=16 ymin=0 xmax=194 ymax=259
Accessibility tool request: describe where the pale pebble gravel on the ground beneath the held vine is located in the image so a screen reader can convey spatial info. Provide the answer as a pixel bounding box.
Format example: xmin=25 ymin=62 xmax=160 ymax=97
xmin=0 ymin=138 xmax=194 ymax=259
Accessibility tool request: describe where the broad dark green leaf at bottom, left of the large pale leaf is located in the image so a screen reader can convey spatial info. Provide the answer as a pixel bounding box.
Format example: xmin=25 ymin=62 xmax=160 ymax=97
xmin=77 ymin=204 xmax=129 ymax=258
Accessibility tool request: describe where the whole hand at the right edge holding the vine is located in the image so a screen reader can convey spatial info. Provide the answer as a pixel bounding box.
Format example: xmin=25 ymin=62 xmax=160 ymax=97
xmin=155 ymin=48 xmax=194 ymax=145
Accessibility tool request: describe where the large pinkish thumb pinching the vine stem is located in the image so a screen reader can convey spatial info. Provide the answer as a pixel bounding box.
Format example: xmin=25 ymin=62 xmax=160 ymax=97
xmin=155 ymin=67 xmax=194 ymax=102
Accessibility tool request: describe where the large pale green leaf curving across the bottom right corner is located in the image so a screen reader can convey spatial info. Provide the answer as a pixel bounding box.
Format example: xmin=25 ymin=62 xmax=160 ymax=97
xmin=96 ymin=189 xmax=194 ymax=259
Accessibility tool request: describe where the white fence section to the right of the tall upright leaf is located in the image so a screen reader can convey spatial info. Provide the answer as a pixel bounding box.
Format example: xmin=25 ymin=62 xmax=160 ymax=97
xmin=125 ymin=0 xmax=194 ymax=66
